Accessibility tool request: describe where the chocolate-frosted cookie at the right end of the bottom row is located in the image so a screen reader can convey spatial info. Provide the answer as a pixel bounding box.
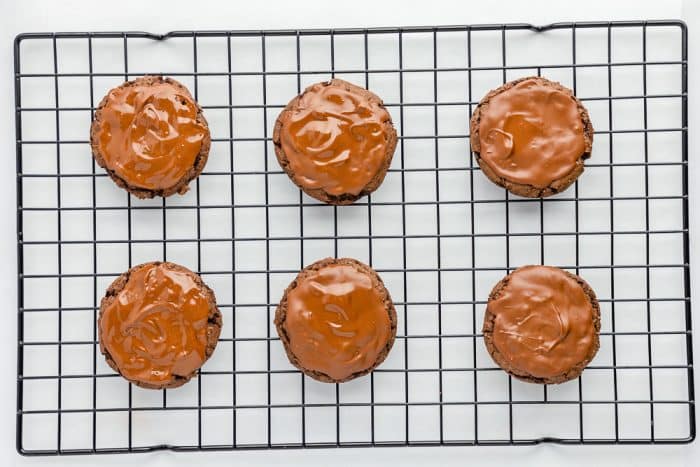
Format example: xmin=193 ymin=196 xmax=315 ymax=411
xmin=483 ymin=266 xmax=600 ymax=384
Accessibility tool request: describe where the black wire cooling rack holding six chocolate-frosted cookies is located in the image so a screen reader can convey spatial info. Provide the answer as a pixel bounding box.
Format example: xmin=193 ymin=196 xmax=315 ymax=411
xmin=15 ymin=21 xmax=695 ymax=454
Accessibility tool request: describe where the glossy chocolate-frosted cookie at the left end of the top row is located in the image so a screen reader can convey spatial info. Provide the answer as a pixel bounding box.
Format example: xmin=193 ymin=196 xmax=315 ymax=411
xmin=90 ymin=76 xmax=211 ymax=198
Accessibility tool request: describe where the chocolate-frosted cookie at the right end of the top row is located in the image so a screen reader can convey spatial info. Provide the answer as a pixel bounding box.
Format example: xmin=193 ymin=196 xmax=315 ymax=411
xmin=470 ymin=77 xmax=593 ymax=198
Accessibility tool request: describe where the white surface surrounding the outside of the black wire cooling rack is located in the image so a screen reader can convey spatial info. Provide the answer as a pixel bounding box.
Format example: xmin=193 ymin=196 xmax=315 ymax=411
xmin=0 ymin=0 xmax=700 ymax=466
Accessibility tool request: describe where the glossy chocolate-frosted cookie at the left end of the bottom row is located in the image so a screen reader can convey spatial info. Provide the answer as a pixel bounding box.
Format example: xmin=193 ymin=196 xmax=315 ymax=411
xmin=98 ymin=262 xmax=222 ymax=389
